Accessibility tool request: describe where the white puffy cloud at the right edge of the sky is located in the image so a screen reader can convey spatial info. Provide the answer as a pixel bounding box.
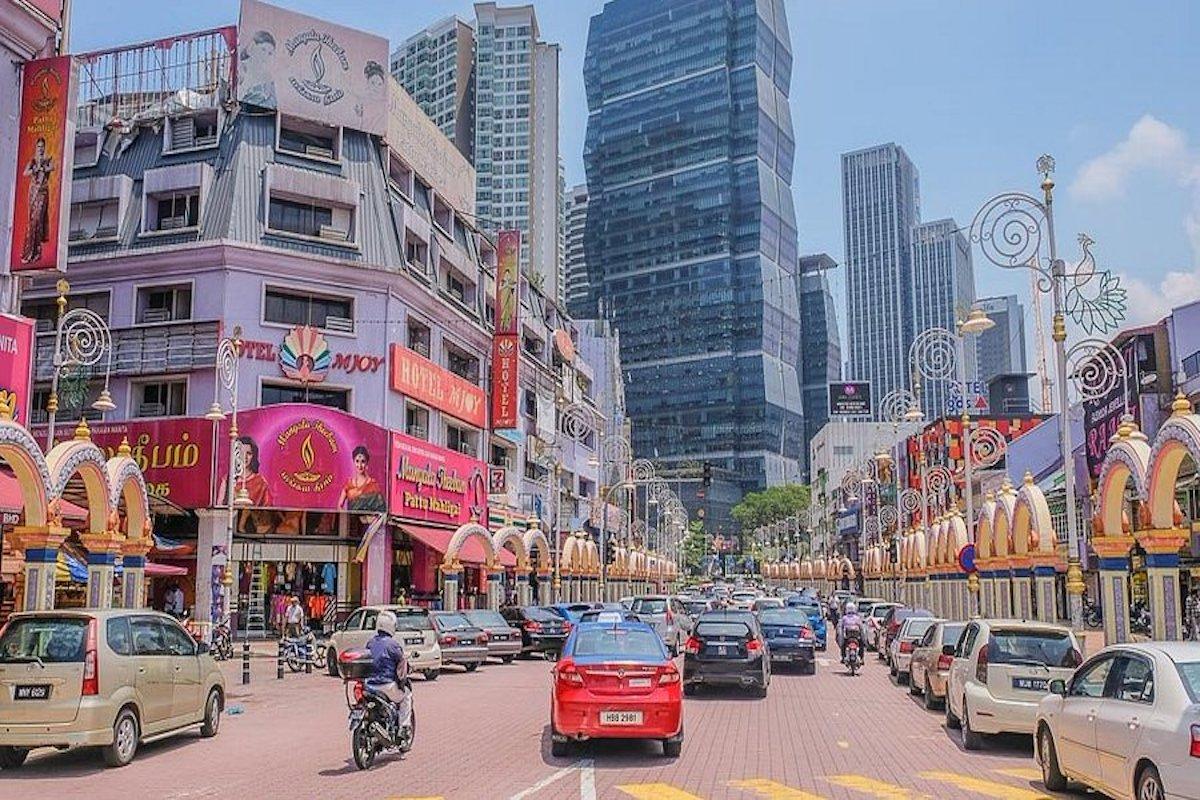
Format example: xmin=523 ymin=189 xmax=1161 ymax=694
xmin=1070 ymin=114 xmax=1200 ymax=263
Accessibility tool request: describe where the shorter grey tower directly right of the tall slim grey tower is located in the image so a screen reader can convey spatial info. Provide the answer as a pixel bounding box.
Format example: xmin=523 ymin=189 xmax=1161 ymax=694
xmin=912 ymin=219 xmax=986 ymax=420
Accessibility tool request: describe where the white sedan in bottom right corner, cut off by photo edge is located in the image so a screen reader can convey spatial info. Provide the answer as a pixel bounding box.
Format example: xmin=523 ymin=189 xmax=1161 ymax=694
xmin=1037 ymin=642 xmax=1200 ymax=800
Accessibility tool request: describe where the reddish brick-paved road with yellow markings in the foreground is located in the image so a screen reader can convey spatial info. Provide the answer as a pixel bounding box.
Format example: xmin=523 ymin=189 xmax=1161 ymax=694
xmin=0 ymin=658 xmax=1089 ymax=800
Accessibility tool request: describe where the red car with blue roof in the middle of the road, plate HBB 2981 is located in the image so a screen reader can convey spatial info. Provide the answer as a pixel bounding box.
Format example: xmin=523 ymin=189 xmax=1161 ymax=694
xmin=550 ymin=614 xmax=683 ymax=757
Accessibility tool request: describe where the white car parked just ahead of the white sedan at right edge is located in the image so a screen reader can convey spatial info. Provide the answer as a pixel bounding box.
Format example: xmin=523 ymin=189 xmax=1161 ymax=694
xmin=946 ymin=619 xmax=1084 ymax=750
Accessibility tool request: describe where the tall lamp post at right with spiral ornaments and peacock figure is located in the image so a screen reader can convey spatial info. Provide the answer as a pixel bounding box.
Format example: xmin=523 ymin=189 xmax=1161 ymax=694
xmin=971 ymin=155 xmax=1126 ymax=631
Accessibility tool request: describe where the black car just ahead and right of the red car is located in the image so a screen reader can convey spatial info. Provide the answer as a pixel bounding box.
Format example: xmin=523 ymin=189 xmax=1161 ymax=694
xmin=683 ymin=610 xmax=770 ymax=697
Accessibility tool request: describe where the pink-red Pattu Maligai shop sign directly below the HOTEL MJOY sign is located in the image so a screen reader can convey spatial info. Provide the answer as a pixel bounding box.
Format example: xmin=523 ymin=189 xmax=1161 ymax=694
xmin=388 ymin=433 xmax=487 ymax=525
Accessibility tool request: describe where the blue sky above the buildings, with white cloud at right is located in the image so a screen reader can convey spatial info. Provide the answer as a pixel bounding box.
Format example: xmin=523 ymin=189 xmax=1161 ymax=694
xmin=72 ymin=0 xmax=1200 ymax=338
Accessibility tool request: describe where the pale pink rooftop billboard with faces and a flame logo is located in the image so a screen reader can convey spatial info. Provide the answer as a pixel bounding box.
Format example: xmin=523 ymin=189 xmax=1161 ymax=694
xmin=238 ymin=0 xmax=389 ymax=136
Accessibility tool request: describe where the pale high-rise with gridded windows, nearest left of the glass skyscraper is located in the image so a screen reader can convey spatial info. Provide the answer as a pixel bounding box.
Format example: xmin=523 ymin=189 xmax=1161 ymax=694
xmin=475 ymin=2 xmax=563 ymax=300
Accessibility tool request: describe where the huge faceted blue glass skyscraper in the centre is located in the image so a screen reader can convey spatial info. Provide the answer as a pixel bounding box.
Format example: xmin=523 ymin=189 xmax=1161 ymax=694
xmin=583 ymin=0 xmax=803 ymax=491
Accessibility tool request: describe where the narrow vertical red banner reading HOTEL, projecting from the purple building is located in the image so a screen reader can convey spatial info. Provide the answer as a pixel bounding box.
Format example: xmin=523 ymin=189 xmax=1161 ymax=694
xmin=492 ymin=230 xmax=521 ymax=431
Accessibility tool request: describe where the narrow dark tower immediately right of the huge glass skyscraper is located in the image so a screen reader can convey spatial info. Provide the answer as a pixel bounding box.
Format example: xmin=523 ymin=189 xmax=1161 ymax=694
xmin=796 ymin=253 xmax=841 ymax=482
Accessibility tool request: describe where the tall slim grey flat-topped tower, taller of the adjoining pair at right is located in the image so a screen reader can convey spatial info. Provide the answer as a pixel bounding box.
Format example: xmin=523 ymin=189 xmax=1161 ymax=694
xmin=841 ymin=143 xmax=920 ymax=417
